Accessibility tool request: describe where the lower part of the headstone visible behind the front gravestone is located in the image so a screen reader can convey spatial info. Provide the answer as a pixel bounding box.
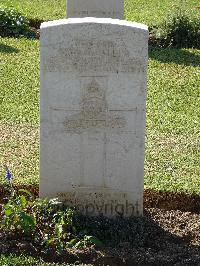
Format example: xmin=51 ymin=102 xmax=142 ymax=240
xmin=67 ymin=0 xmax=124 ymax=19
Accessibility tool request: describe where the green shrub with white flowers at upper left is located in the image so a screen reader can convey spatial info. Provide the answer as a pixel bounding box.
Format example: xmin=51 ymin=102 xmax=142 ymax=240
xmin=0 ymin=7 xmax=33 ymax=37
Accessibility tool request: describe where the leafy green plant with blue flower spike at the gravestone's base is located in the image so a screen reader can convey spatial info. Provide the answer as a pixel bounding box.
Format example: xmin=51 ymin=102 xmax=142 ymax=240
xmin=0 ymin=167 xmax=103 ymax=253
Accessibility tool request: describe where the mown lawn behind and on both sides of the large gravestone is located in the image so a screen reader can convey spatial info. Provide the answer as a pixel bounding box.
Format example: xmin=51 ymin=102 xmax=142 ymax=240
xmin=0 ymin=0 xmax=200 ymax=194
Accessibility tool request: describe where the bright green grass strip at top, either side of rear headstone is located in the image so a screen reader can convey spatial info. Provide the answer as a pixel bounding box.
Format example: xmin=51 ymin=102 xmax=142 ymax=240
xmin=1 ymin=0 xmax=199 ymax=25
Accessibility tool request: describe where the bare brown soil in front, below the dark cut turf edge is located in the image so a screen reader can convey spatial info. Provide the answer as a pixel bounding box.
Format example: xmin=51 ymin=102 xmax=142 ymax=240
xmin=0 ymin=208 xmax=200 ymax=266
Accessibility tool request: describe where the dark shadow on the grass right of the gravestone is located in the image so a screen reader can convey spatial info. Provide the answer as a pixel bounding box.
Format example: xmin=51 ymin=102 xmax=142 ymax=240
xmin=149 ymin=47 xmax=200 ymax=67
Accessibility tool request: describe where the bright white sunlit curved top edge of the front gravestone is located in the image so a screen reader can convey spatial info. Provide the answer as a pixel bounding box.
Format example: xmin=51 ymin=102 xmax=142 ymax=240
xmin=40 ymin=17 xmax=148 ymax=32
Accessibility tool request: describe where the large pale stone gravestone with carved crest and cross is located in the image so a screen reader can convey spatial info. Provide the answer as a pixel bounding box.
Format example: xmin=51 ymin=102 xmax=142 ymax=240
xmin=40 ymin=0 xmax=148 ymax=217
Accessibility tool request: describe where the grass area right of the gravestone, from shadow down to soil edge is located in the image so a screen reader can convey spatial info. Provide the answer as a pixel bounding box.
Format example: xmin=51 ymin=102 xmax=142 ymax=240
xmin=145 ymin=49 xmax=200 ymax=193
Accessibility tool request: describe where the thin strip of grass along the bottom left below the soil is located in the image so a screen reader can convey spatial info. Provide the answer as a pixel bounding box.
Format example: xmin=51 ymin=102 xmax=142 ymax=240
xmin=0 ymin=255 xmax=89 ymax=266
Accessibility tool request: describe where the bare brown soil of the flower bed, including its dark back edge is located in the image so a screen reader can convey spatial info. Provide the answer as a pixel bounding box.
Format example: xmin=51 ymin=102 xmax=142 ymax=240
xmin=0 ymin=187 xmax=200 ymax=266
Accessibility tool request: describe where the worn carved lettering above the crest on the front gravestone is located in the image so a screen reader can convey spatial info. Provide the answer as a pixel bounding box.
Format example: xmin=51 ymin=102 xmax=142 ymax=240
xmin=43 ymin=40 xmax=144 ymax=73
